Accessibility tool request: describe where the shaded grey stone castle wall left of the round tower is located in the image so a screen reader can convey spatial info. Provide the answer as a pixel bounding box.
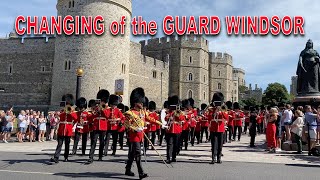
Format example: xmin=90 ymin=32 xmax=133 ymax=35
xmin=0 ymin=38 xmax=55 ymax=110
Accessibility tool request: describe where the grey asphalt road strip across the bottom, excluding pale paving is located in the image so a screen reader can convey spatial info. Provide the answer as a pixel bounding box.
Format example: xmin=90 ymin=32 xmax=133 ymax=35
xmin=0 ymin=152 xmax=320 ymax=180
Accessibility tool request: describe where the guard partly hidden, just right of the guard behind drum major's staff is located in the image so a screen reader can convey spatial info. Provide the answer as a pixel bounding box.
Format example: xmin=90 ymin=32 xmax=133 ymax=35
xmin=180 ymin=99 xmax=193 ymax=150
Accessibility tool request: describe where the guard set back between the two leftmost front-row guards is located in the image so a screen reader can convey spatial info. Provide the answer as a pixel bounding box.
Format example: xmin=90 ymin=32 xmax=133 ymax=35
xmin=72 ymin=97 xmax=89 ymax=155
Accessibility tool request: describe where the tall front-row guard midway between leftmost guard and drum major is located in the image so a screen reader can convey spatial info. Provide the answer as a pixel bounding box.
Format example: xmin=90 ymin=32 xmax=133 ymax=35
xmin=86 ymin=89 xmax=110 ymax=164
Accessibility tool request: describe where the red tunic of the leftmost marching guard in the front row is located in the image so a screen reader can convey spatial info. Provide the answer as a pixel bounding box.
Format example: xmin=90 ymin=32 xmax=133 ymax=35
xmin=57 ymin=112 xmax=78 ymax=137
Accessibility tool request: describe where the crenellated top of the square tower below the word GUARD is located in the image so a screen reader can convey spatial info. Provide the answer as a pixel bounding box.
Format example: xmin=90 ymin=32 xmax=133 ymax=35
xmin=140 ymin=35 xmax=209 ymax=51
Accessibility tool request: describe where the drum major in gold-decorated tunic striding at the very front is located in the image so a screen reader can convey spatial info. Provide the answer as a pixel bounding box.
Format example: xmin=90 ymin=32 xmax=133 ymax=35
xmin=124 ymin=88 xmax=148 ymax=179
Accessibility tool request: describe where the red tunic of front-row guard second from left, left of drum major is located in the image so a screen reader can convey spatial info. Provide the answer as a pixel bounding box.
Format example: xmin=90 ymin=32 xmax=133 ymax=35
xmin=92 ymin=108 xmax=110 ymax=131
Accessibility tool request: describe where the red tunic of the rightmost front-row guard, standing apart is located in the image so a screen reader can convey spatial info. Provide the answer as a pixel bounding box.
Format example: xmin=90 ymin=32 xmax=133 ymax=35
xmin=209 ymin=111 xmax=228 ymax=132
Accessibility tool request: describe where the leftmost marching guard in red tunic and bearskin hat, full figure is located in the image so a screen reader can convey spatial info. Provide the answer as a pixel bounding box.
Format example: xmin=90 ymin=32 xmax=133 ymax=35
xmin=50 ymin=94 xmax=78 ymax=163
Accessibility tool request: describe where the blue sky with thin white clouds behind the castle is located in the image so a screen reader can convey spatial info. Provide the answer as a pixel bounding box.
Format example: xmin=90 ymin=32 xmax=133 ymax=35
xmin=0 ymin=0 xmax=320 ymax=91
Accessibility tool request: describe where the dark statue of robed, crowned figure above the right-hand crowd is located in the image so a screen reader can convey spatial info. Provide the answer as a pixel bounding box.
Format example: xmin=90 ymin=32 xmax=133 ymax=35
xmin=297 ymin=39 xmax=320 ymax=96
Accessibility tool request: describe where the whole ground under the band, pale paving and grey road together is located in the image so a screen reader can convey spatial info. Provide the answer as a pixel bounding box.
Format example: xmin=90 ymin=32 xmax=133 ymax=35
xmin=0 ymin=137 xmax=320 ymax=180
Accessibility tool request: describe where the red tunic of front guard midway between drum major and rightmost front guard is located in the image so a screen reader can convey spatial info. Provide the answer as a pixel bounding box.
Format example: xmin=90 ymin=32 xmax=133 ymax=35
xmin=165 ymin=111 xmax=185 ymax=134
